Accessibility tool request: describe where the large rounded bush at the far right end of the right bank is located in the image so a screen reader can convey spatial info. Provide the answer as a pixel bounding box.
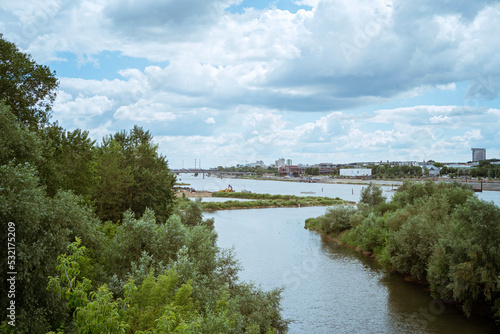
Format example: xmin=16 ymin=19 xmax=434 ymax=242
xmin=429 ymin=198 xmax=500 ymax=314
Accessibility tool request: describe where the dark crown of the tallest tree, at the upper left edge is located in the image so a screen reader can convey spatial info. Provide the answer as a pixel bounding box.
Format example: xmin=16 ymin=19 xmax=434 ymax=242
xmin=0 ymin=34 xmax=58 ymax=129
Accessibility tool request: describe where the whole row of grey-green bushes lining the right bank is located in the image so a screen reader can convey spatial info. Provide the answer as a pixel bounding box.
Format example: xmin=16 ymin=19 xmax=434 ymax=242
xmin=306 ymin=181 xmax=500 ymax=319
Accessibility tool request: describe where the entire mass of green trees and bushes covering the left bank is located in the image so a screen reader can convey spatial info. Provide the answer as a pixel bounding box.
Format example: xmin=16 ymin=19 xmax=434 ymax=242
xmin=0 ymin=36 xmax=288 ymax=333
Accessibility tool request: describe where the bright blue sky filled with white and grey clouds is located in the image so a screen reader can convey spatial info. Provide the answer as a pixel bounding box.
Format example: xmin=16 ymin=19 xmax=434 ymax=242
xmin=0 ymin=0 xmax=500 ymax=168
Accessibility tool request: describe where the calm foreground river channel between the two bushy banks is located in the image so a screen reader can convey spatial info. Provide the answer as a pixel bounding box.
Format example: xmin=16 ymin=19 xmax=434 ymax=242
xmin=205 ymin=207 xmax=499 ymax=333
